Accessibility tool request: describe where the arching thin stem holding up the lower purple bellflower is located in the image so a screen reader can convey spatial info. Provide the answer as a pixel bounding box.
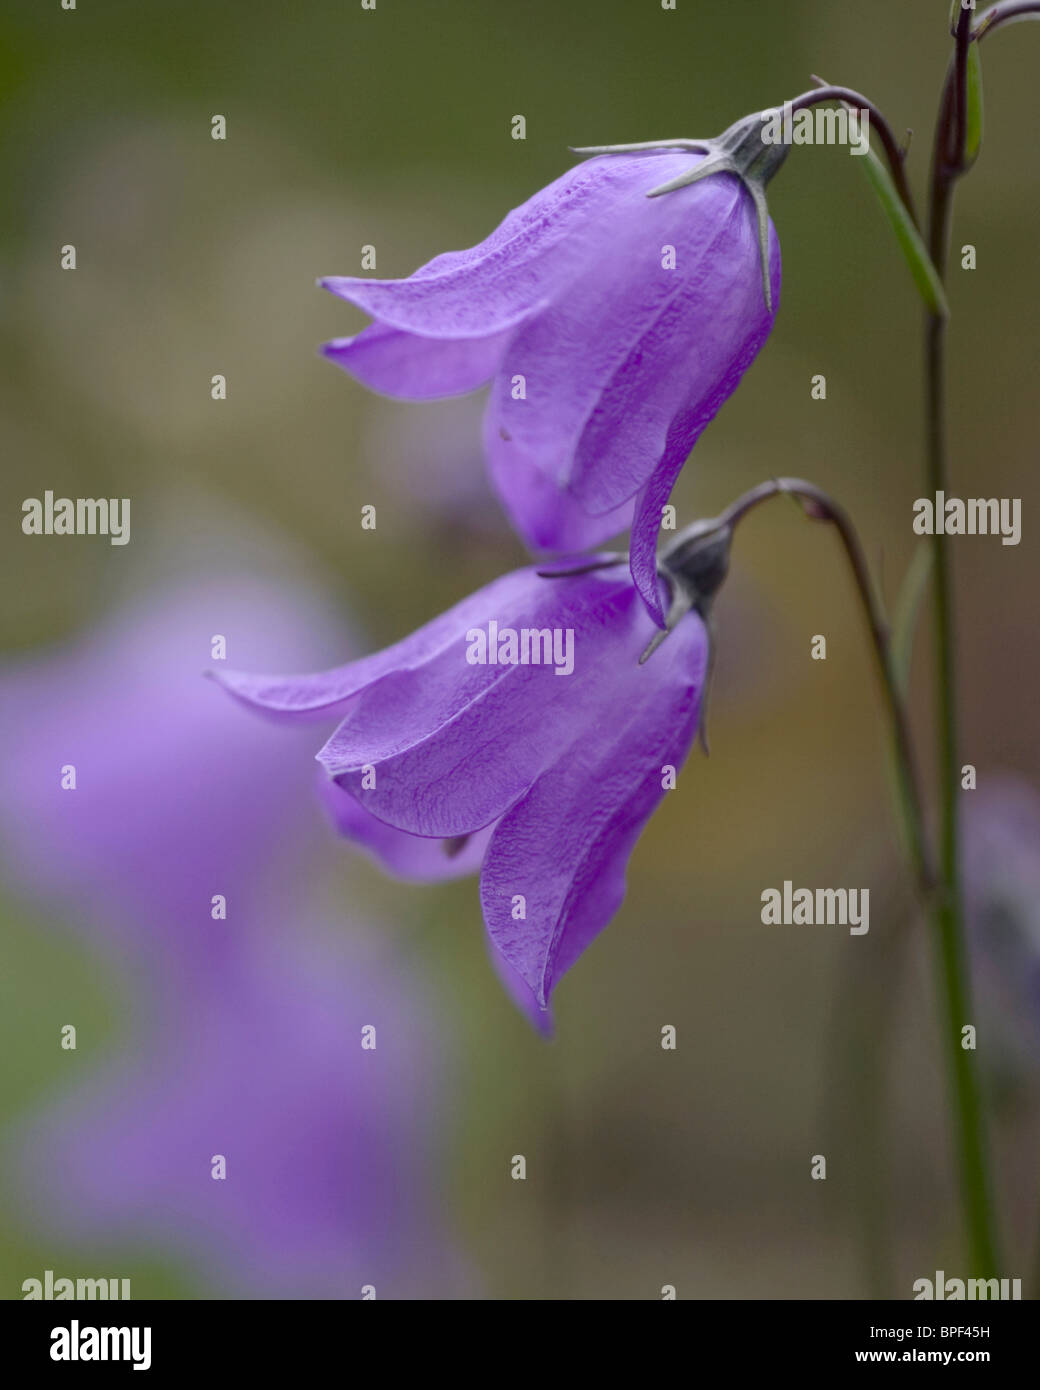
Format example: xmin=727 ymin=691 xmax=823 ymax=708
xmin=719 ymin=478 xmax=936 ymax=899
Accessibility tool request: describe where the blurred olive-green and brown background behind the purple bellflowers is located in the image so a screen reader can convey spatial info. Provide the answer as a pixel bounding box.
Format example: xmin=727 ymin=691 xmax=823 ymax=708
xmin=0 ymin=0 xmax=1040 ymax=1298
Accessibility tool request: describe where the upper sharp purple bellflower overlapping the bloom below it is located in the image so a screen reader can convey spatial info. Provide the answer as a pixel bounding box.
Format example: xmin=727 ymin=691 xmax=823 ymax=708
xmin=321 ymin=115 xmax=787 ymax=624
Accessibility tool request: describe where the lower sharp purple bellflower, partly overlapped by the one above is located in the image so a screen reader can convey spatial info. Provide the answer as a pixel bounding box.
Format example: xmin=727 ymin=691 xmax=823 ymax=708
xmin=214 ymin=559 xmax=708 ymax=1029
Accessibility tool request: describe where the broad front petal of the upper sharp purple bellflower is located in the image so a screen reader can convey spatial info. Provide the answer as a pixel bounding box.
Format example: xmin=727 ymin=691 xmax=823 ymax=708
xmin=484 ymin=156 xmax=780 ymax=558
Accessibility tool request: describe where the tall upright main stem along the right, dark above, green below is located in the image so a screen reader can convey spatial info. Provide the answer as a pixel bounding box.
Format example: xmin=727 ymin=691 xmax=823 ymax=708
xmin=925 ymin=2 xmax=997 ymax=1277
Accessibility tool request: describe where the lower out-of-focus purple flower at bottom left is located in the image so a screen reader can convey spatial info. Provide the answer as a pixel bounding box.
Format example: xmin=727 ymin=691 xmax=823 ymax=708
xmin=22 ymin=906 xmax=459 ymax=1298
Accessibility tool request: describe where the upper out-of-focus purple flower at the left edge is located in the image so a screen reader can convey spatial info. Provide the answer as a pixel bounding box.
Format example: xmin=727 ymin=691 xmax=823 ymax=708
xmin=0 ymin=575 xmax=436 ymax=952
